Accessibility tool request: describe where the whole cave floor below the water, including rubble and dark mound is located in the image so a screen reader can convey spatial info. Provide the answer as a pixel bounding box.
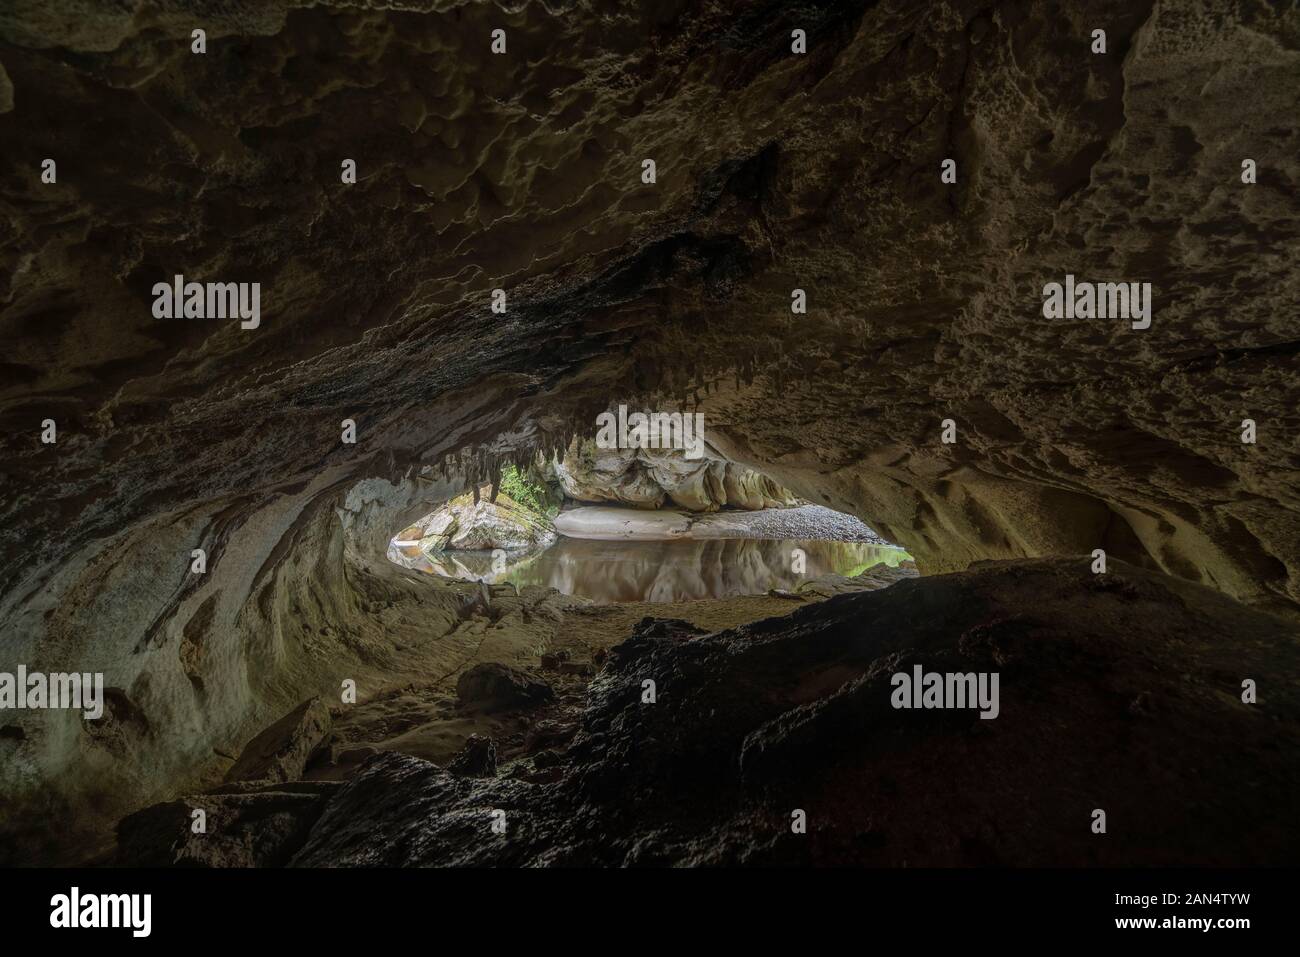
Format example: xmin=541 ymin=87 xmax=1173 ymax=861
xmin=111 ymin=559 xmax=1300 ymax=866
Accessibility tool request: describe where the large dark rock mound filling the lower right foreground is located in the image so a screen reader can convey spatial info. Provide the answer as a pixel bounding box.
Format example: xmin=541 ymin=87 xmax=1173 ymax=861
xmin=295 ymin=559 xmax=1300 ymax=866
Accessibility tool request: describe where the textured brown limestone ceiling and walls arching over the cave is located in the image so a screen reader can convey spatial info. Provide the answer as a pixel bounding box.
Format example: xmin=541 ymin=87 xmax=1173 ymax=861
xmin=0 ymin=0 xmax=1300 ymax=863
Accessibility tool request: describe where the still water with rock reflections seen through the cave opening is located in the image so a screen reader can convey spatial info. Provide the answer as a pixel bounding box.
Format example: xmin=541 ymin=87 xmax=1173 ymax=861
xmin=390 ymin=537 xmax=909 ymax=605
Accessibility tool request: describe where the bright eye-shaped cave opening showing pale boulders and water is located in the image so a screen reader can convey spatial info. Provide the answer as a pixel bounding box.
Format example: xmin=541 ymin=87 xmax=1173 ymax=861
xmin=387 ymin=439 xmax=914 ymax=603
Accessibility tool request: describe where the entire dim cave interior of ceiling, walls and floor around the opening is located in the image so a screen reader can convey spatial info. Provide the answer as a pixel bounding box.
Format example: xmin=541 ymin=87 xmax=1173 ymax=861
xmin=0 ymin=0 xmax=1300 ymax=867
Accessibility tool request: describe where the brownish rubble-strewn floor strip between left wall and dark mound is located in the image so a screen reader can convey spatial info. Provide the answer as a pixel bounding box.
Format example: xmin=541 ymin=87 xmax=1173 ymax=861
xmin=104 ymin=564 xmax=917 ymax=866
